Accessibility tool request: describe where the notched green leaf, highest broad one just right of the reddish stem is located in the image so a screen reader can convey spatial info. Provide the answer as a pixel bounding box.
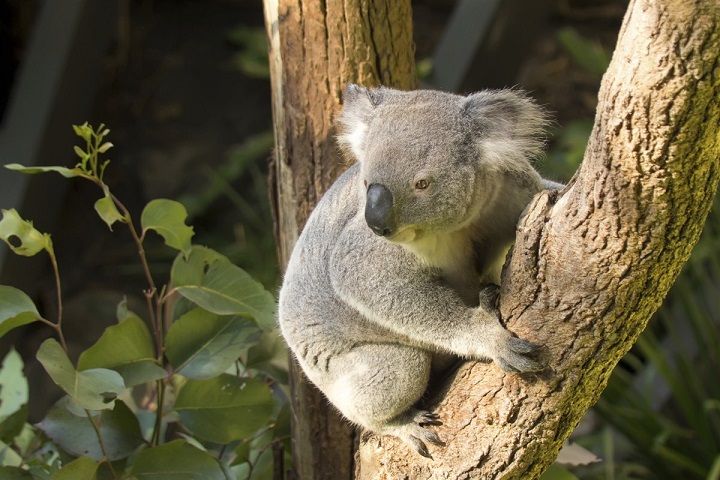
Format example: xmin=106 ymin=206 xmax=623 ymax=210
xmin=140 ymin=198 xmax=193 ymax=256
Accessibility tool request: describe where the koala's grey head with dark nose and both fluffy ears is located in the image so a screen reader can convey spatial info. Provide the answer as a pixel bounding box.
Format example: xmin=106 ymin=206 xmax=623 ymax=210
xmin=337 ymin=85 xmax=546 ymax=242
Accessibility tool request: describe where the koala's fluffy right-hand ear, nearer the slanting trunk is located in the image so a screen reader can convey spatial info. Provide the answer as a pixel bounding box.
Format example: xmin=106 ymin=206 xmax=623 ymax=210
xmin=463 ymin=90 xmax=548 ymax=165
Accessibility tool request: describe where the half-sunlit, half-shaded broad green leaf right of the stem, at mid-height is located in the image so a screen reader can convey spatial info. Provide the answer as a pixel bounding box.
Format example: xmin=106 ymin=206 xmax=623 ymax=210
xmin=165 ymin=308 xmax=261 ymax=380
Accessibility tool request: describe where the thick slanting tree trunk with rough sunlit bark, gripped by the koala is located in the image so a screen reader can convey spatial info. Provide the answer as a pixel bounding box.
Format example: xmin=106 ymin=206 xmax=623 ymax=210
xmin=356 ymin=0 xmax=720 ymax=479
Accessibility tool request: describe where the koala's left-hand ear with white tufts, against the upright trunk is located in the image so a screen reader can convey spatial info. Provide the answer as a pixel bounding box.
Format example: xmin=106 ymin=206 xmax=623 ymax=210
xmin=336 ymin=84 xmax=386 ymax=160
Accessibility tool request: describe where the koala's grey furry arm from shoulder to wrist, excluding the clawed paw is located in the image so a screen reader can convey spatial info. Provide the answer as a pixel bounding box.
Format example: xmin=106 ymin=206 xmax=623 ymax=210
xmin=330 ymin=242 xmax=502 ymax=358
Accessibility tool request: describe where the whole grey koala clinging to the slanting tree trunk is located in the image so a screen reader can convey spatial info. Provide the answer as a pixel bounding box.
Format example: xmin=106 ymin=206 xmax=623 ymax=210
xmin=278 ymin=85 xmax=560 ymax=457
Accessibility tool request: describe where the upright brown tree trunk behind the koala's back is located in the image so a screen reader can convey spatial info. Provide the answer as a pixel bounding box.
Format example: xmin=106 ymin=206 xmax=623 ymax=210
xmin=264 ymin=0 xmax=416 ymax=480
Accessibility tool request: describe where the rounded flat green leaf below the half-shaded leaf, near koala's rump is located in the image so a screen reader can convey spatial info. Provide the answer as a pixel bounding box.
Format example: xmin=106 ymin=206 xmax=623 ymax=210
xmin=175 ymin=374 xmax=274 ymax=444
